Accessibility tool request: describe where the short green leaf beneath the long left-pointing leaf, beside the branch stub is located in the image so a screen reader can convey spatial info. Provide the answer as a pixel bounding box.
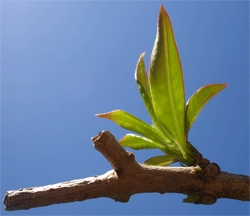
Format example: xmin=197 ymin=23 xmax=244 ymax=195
xmin=119 ymin=134 xmax=162 ymax=150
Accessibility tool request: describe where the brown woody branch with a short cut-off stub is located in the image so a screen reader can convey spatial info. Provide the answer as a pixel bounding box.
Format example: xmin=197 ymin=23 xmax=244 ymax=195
xmin=4 ymin=131 xmax=250 ymax=210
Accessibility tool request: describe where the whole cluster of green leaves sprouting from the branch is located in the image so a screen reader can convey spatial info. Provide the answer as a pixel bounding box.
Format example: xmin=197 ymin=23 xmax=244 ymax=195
xmin=96 ymin=5 xmax=227 ymax=166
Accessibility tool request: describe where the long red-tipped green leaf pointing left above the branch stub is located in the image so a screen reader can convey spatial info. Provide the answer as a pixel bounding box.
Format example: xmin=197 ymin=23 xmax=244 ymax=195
xmin=96 ymin=110 xmax=165 ymax=147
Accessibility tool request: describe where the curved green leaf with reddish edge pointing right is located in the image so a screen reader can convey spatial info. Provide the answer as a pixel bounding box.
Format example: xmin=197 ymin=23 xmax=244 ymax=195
xmin=186 ymin=84 xmax=227 ymax=133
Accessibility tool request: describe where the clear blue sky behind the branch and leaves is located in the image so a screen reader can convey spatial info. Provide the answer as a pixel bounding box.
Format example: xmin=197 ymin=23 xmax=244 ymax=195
xmin=1 ymin=1 xmax=249 ymax=215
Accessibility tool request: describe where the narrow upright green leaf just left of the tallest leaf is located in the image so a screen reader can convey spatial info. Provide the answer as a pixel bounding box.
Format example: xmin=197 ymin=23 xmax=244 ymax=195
xmin=135 ymin=53 xmax=174 ymax=143
